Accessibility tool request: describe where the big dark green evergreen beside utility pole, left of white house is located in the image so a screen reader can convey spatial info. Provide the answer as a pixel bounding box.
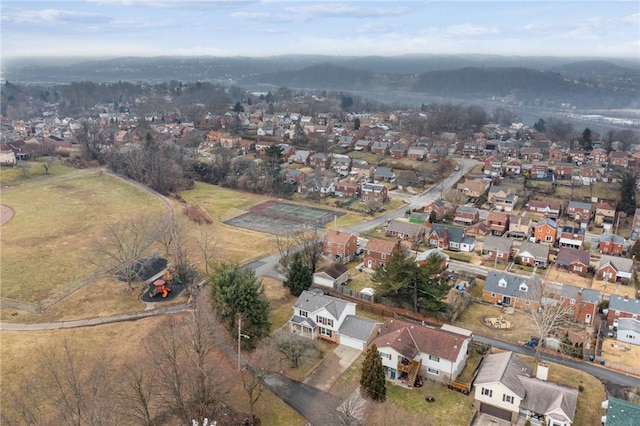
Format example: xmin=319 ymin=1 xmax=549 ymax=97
xmin=208 ymin=263 xmax=271 ymax=349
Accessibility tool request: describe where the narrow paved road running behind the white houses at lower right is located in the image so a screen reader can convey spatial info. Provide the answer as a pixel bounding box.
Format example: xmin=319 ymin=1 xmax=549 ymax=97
xmin=473 ymin=334 xmax=640 ymax=387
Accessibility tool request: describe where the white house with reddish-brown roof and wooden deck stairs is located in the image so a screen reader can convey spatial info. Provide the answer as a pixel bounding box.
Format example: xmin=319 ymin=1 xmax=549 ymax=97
xmin=373 ymin=318 xmax=471 ymax=386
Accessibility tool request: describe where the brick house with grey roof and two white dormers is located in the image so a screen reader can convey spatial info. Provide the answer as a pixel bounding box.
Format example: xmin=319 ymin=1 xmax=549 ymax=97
xmin=482 ymin=271 xmax=542 ymax=310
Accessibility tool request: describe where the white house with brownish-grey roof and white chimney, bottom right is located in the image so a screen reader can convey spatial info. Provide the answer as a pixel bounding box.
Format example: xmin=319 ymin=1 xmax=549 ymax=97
xmin=474 ymin=351 xmax=578 ymax=426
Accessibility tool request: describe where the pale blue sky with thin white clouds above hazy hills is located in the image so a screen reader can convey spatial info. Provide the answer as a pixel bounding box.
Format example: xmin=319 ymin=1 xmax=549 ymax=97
xmin=1 ymin=0 xmax=640 ymax=59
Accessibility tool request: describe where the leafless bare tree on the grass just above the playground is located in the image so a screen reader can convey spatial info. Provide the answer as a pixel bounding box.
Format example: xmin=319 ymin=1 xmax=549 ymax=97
xmin=90 ymin=215 xmax=162 ymax=291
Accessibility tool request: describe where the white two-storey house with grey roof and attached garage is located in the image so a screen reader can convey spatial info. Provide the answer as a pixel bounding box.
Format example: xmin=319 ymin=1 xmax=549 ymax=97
xmin=289 ymin=290 xmax=379 ymax=350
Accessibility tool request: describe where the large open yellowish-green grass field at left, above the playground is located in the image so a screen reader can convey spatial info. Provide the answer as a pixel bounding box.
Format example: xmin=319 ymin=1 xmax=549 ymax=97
xmin=0 ymin=170 xmax=165 ymax=303
